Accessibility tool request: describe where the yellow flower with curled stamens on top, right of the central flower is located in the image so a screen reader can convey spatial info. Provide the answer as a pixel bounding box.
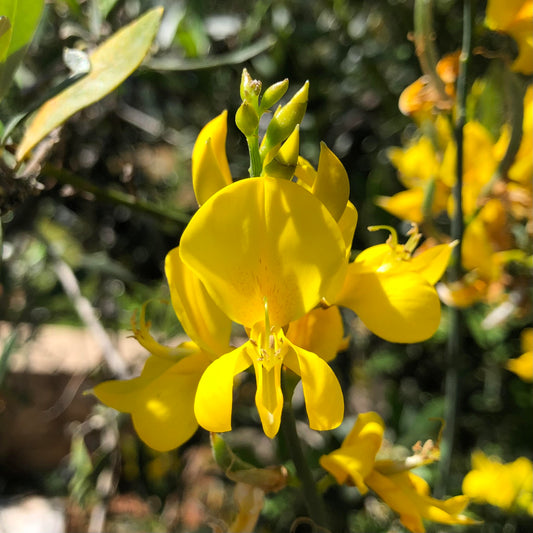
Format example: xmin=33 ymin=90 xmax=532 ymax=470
xmin=334 ymin=226 xmax=450 ymax=343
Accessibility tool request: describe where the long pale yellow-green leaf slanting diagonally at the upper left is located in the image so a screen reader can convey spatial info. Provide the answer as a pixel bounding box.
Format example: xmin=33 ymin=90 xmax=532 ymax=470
xmin=16 ymin=7 xmax=163 ymax=160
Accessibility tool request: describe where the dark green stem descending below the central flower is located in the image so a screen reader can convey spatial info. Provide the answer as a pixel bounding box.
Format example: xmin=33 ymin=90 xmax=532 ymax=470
xmin=281 ymin=391 xmax=328 ymax=528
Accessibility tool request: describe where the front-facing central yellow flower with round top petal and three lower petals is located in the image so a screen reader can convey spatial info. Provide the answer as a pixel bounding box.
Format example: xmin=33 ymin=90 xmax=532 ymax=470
xmin=179 ymin=177 xmax=346 ymax=437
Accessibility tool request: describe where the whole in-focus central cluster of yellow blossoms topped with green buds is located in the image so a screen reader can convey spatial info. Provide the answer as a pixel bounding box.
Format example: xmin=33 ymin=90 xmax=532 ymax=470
xmin=94 ymin=71 xmax=453 ymax=450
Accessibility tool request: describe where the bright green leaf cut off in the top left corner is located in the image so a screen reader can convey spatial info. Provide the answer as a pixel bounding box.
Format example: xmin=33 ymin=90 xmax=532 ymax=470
xmin=0 ymin=0 xmax=44 ymax=99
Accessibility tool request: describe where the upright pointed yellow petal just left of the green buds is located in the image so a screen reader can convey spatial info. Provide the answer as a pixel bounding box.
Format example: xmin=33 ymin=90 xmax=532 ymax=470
xmin=192 ymin=111 xmax=232 ymax=205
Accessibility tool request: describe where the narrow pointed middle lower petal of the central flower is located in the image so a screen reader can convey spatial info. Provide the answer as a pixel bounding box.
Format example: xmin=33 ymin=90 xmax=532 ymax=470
xmin=253 ymin=357 xmax=283 ymax=439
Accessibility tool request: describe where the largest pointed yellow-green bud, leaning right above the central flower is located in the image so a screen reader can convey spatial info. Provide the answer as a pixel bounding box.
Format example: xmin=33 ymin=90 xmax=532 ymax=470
xmin=260 ymin=81 xmax=309 ymax=159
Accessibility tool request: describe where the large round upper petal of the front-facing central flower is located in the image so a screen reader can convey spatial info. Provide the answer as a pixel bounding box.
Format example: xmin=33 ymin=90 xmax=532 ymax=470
xmin=180 ymin=177 xmax=346 ymax=327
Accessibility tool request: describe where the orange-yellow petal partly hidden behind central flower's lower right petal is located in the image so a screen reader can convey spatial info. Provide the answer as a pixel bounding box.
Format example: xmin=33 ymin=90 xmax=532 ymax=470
xmin=287 ymin=306 xmax=344 ymax=361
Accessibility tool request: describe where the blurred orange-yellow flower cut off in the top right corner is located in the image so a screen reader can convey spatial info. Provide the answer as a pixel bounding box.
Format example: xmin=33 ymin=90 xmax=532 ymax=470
xmin=485 ymin=0 xmax=533 ymax=74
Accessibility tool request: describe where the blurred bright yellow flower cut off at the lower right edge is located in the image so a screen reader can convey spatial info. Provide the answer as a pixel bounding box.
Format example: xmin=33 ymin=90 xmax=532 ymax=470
xmin=463 ymin=450 xmax=533 ymax=515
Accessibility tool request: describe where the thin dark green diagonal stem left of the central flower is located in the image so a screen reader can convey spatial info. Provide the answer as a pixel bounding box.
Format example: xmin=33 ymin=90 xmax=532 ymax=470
xmin=42 ymin=165 xmax=190 ymax=224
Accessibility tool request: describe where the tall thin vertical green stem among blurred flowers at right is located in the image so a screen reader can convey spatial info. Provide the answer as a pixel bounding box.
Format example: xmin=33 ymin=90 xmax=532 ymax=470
xmin=438 ymin=0 xmax=472 ymax=494
